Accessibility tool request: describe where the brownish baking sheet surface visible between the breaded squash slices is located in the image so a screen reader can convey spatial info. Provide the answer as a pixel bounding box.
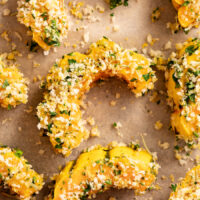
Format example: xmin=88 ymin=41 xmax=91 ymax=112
xmin=0 ymin=0 xmax=198 ymax=200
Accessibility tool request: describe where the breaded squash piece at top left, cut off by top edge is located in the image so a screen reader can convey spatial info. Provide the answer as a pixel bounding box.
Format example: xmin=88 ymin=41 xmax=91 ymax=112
xmin=17 ymin=0 xmax=68 ymax=51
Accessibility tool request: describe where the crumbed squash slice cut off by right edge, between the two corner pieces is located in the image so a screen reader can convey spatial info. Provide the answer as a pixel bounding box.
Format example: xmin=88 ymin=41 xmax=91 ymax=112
xmin=166 ymin=38 xmax=200 ymax=142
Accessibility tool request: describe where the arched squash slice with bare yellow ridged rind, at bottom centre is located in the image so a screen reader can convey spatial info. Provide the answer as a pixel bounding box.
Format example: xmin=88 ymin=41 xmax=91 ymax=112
xmin=48 ymin=143 xmax=158 ymax=200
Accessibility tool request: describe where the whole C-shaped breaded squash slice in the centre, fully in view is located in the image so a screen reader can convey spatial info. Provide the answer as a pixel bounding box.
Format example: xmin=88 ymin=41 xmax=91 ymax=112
xmin=37 ymin=38 xmax=156 ymax=156
